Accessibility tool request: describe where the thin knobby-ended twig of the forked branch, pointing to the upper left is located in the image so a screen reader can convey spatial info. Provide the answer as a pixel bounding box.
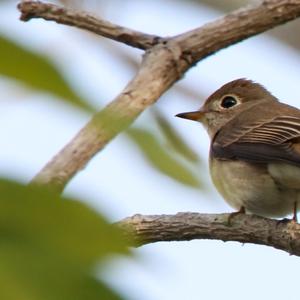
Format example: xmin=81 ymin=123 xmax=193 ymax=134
xmin=18 ymin=1 xmax=160 ymax=50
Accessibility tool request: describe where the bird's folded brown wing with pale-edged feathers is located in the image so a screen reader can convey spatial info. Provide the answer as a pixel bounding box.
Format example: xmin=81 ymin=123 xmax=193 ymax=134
xmin=211 ymin=115 xmax=300 ymax=166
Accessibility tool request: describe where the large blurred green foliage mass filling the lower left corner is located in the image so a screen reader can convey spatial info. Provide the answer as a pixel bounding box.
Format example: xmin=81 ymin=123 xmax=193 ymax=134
xmin=0 ymin=180 xmax=129 ymax=300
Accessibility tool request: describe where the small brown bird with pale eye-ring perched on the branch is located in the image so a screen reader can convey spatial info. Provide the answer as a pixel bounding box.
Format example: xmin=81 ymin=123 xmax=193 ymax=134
xmin=176 ymin=78 xmax=300 ymax=222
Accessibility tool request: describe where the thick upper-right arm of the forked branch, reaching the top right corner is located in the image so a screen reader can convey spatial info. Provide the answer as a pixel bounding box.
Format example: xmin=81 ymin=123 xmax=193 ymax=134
xmin=174 ymin=0 xmax=300 ymax=64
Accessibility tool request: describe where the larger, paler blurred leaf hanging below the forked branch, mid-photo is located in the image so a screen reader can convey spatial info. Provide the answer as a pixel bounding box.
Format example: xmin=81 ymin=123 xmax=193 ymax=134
xmin=127 ymin=128 xmax=200 ymax=187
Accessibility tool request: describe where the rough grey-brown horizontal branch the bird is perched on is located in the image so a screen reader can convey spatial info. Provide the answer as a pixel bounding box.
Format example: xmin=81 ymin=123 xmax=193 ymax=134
xmin=117 ymin=213 xmax=300 ymax=256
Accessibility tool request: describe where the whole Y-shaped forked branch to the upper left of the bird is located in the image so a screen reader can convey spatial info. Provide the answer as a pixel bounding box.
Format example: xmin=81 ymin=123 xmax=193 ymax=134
xmin=19 ymin=0 xmax=300 ymax=191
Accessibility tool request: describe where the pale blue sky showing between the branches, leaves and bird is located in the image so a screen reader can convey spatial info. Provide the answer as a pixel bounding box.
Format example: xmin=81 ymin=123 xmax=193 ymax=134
xmin=0 ymin=0 xmax=300 ymax=300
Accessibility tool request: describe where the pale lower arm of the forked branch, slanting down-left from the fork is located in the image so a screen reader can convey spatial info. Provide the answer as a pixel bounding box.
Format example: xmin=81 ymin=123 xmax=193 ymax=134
xmin=28 ymin=45 xmax=180 ymax=191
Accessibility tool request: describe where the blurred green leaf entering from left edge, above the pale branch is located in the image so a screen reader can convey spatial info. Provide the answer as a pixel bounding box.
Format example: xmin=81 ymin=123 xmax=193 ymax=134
xmin=0 ymin=36 xmax=93 ymax=112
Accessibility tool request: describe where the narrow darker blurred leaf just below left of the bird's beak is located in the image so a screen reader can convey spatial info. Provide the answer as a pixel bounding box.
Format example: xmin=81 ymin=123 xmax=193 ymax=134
xmin=152 ymin=108 xmax=200 ymax=163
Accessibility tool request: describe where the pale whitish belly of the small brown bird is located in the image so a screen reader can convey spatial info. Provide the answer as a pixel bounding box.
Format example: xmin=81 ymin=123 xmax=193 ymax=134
xmin=210 ymin=159 xmax=300 ymax=217
